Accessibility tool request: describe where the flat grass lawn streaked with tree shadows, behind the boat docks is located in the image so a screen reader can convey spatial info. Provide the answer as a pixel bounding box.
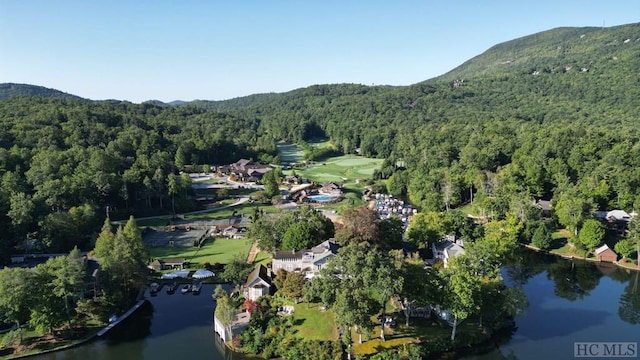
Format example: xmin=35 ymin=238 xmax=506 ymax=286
xmin=149 ymin=238 xmax=252 ymax=265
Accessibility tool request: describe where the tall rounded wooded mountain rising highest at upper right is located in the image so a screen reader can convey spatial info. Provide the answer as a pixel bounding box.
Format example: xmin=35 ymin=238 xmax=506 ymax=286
xmin=429 ymin=23 xmax=640 ymax=81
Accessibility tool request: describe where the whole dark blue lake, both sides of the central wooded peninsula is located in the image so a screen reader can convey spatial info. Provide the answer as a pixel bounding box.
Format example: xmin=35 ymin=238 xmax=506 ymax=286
xmin=33 ymin=251 xmax=640 ymax=360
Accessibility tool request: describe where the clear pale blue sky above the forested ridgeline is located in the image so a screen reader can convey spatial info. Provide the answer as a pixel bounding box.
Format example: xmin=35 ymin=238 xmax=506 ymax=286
xmin=0 ymin=0 xmax=640 ymax=102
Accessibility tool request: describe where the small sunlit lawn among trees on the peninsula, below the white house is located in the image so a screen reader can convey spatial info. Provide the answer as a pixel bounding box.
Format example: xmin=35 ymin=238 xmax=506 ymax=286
xmin=292 ymin=303 xmax=338 ymax=341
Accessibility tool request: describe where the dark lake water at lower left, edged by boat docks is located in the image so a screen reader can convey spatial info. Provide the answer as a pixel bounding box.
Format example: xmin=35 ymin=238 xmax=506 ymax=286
xmin=35 ymin=284 xmax=245 ymax=360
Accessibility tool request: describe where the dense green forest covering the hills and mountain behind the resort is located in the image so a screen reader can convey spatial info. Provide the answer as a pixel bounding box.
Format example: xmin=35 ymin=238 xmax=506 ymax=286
xmin=0 ymin=24 xmax=640 ymax=260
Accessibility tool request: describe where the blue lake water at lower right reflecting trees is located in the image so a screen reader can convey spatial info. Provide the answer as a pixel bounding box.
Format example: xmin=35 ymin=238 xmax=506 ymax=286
xmin=465 ymin=251 xmax=640 ymax=360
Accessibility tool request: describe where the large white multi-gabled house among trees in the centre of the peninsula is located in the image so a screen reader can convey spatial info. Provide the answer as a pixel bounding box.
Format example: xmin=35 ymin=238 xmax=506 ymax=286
xmin=271 ymin=239 xmax=339 ymax=278
